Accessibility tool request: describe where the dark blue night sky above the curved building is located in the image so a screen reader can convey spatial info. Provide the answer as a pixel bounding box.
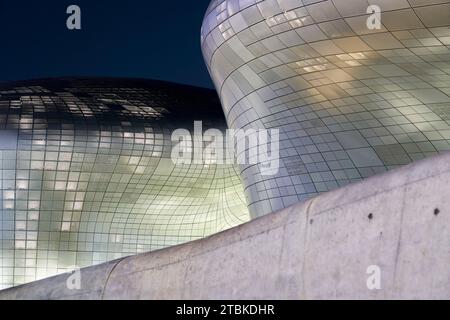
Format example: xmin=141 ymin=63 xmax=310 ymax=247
xmin=0 ymin=0 xmax=212 ymax=87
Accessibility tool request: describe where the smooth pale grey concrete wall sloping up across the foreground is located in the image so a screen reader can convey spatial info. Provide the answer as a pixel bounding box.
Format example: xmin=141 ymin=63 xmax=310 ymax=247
xmin=0 ymin=153 xmax=450 ymax=299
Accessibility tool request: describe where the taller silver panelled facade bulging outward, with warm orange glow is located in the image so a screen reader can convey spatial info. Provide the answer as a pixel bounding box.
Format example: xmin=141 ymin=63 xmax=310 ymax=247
xmin=202 ymin=0 xmax=450 ymax=215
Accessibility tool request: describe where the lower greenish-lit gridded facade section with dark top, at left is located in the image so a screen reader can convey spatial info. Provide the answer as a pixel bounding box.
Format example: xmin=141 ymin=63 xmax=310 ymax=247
xmin=0 ymin=79 xmax=249 ymax=288
